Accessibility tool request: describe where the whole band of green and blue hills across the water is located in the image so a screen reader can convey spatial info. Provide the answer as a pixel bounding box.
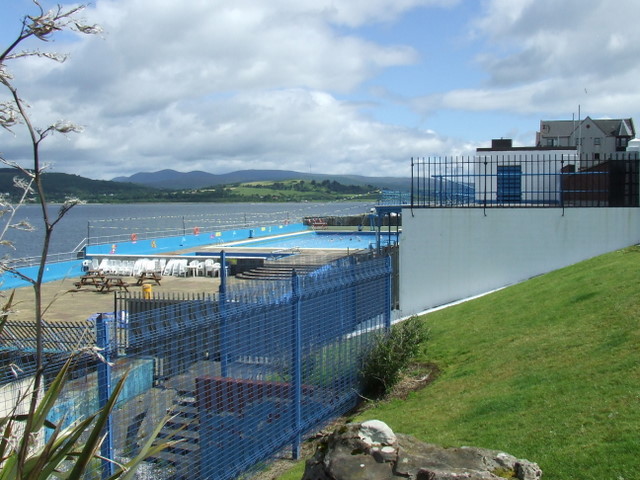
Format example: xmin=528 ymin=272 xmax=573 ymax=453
xmin=0 ymin=168 xmax=409 ymax=203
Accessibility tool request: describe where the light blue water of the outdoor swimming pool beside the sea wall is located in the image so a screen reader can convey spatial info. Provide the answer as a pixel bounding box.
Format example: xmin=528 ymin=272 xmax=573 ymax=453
xmin=233 ymin=231 xmax=396 ymax=250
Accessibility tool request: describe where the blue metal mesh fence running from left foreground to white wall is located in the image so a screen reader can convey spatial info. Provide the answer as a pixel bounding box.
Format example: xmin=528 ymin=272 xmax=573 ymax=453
xmin=0 ymin=256 xmax=391 ymax=480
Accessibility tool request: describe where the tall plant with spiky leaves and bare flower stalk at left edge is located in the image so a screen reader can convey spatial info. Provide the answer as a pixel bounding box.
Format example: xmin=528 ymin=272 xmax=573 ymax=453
xmin=0 ymin=4 xmax=174 ymax=480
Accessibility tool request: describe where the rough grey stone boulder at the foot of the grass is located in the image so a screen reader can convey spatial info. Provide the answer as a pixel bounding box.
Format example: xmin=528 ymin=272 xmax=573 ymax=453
xmin=302 ymin=420 xmax=542 ymax=480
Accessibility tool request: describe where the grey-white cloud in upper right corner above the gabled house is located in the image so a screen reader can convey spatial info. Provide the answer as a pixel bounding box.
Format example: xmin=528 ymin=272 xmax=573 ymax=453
xmin=414 ymin=0 xmax=640 ymax=120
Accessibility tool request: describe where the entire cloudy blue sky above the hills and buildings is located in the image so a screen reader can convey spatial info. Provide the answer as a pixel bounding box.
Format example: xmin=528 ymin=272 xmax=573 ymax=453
xmin=0 ymin=0 xmax=640 ymax=180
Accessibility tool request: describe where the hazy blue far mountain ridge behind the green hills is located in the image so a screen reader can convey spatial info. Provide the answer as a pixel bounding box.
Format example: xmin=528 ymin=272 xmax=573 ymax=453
xmin=113 ymin=170 xmax=411 ymax=191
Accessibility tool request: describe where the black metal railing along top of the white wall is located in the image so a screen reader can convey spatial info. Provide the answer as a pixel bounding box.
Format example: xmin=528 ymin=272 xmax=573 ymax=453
xmin=411 ymin=152 xmax=640 ymax=208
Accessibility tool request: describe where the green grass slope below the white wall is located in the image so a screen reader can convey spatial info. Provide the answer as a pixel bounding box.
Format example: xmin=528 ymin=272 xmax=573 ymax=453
xmin=357 ymin=247 xmax=640 ymax=480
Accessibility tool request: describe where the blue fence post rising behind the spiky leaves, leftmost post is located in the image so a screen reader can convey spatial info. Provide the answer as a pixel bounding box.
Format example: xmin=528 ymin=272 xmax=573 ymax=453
xmin=96 ymin=313 xmax=115 ymax=478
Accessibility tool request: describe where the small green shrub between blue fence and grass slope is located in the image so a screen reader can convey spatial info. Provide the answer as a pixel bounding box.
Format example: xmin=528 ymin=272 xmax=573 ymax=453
xmin=360 ymin=317 xmax=429 ymax=398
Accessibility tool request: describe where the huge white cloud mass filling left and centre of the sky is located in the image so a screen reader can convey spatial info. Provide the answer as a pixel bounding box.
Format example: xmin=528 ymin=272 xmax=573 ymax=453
xmin=1 ymin=0 xmax=456 ymax=178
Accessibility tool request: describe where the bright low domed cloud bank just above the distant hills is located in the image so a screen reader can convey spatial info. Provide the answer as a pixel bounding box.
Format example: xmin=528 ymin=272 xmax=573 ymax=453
xmin=52 ymin=89 xmax=462 ymax=178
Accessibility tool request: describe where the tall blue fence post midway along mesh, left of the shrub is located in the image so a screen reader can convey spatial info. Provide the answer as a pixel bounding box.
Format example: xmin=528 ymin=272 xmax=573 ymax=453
xmin=291 ymin=269 xmax=302 ymax=460
